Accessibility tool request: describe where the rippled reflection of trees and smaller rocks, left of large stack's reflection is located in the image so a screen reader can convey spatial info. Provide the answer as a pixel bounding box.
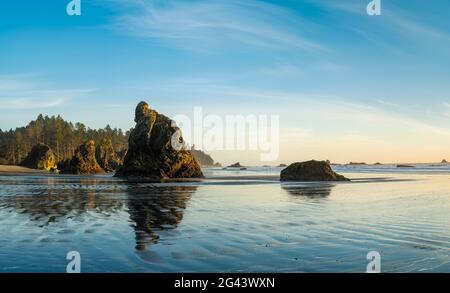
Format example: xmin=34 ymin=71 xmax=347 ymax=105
xmin=0 ymin=178 xmax=123 ymax=227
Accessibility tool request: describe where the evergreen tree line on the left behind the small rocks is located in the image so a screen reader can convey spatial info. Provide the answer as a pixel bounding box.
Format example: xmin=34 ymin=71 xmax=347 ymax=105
xmin=0 ymin=114 xmax=130 ymax=165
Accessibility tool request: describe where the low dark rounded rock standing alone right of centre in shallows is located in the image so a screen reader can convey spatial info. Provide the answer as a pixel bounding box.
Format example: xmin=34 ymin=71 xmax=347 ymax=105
xmin=280 ymin=160 xmax=350 ymax=181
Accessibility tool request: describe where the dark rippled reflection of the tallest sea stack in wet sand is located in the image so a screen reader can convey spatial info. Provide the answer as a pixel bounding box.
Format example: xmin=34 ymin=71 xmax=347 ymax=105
xmin=127 ymin=184 xmax=197 ymax=251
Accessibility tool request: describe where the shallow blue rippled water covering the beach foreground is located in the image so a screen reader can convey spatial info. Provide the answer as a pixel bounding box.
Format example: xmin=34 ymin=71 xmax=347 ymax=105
xmin=0 ymin=166 xmax=450 ymax=272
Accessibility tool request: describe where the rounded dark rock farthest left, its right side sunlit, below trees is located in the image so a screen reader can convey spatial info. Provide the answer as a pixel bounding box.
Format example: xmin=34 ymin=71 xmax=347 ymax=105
xmin=20 ymin=143 xmax=57 ymax=171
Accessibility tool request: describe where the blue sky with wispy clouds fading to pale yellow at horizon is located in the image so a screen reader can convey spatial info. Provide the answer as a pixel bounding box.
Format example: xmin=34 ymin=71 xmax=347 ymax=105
xmin=0 ymin=0 xmax=450 ymax=164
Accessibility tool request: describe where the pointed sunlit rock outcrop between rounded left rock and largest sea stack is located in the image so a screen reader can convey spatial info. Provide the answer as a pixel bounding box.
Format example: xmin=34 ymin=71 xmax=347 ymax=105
xmin=58 ymin=140 xmax=104 ymax=174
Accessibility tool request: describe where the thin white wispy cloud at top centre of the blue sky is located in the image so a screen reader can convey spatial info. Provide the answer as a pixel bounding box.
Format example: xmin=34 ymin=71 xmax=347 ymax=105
xmin=107 ymin=0 xmax=323 ymax=51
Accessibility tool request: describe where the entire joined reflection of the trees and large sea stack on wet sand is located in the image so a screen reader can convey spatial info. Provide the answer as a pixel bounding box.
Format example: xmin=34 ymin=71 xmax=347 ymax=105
xmin=0 ymin=173 xmax=197 ymax=250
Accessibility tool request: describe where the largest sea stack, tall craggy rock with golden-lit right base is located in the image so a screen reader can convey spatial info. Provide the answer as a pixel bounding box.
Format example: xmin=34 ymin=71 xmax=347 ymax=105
xmin=115 ymin=102 xmax=203 ymax=181
